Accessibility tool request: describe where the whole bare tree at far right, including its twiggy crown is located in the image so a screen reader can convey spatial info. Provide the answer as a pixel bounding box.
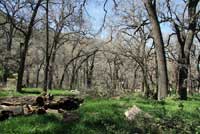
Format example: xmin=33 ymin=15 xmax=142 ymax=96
xmin=165 ymin=0 xmax=200 ymax=100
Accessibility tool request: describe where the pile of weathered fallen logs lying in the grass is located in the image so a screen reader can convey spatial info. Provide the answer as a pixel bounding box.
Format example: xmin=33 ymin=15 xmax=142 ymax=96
xmin=0 ymin=95 xmax=84 ymax=122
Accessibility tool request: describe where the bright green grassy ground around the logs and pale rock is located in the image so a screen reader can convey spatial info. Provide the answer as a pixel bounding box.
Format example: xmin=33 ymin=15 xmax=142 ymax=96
xmin=0 ymin=88 xmax=200 ymax=134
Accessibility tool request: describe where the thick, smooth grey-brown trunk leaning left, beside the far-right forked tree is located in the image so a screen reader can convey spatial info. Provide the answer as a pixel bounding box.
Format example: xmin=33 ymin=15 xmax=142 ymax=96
xmin=143 ymin=0 xmax=168 ymax=100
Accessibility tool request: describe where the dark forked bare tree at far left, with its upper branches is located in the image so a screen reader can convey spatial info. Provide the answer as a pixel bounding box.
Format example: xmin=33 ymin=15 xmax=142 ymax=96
xmin=1 ymin=0 xmax=43 ymax=92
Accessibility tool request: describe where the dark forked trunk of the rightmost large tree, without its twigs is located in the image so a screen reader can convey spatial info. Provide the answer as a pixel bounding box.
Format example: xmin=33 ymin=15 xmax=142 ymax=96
xmin=174 ymin=0 xmax=199 ymax=100
